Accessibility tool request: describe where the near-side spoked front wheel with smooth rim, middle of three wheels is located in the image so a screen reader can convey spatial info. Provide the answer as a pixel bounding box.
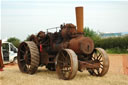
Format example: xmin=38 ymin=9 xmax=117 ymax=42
xmin=56 ymin=49 xmax=78 ymax=80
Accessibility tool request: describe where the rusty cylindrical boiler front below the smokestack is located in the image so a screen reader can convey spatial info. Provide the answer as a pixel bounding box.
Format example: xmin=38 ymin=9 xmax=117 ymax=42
xmin=69 ymin=36 xmax=94 ymax=54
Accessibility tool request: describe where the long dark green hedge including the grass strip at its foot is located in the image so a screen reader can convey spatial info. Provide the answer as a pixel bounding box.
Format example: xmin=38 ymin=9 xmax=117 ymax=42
xmin=95 ymin=36 xmax=128 ymax=53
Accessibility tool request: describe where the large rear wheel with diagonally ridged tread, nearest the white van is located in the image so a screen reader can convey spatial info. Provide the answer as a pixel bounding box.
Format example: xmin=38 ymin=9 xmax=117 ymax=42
xmin=17 ymin=41 xmax=39 ymax=74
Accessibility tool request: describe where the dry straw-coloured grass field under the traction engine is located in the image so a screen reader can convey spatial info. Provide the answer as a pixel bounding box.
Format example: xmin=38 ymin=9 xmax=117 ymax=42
xmin=0 ymin=55 xmax=128 ymax=85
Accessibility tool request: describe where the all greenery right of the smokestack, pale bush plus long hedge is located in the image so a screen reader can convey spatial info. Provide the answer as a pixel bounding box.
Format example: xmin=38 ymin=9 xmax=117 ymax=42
xmin=84 ymin=27 xmax=128 ymax=53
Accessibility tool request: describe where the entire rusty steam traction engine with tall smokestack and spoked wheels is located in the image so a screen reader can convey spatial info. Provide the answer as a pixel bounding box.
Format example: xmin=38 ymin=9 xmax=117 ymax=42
xmin=18 ymin=7 xmax=109 ymax=80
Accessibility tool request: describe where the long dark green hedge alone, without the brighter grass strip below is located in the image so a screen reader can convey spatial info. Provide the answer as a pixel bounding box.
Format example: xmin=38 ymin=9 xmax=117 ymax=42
xmin=96 ymin=36 xmax=128 ymax=49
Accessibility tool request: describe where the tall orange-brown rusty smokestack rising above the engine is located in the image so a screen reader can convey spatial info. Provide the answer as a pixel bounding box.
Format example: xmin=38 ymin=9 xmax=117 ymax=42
xmin=76 ymin=7 xmax=84 ymax=33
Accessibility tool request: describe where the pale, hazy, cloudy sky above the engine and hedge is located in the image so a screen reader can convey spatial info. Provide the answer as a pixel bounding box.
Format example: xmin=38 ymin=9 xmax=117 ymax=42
xmin=0 ymin=0 xmax=128 ymax=40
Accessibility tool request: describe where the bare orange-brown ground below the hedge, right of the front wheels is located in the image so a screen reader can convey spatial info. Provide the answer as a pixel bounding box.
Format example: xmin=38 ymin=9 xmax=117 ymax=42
xmin=108 ymin=54 xmax=128 ymax=74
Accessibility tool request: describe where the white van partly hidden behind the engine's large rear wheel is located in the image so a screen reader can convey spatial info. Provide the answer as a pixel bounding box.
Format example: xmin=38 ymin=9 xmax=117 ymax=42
xmin=2 ymin=42 xmax=18 ymax=64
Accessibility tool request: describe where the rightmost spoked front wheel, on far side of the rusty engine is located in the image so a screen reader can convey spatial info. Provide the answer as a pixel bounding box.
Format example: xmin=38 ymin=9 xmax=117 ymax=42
xmin=87 ymin=48 xmax=109 ymax=76
